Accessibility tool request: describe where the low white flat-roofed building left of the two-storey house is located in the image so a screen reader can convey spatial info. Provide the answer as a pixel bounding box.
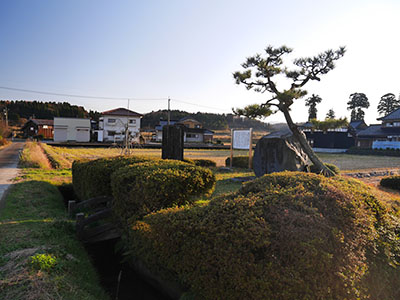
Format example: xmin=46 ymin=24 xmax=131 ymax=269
xmin=53 ymin=117 xmax=90 ymax=142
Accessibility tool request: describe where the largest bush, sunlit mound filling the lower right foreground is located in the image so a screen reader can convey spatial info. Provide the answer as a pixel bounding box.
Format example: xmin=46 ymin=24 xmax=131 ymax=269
xmin=126 ymin=172 xmax=400 ymax=300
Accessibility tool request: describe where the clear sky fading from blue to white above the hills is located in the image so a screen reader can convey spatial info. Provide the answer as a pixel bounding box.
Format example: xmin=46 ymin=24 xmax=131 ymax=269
xmin=0 ymin=0 xmax=400 ymax=124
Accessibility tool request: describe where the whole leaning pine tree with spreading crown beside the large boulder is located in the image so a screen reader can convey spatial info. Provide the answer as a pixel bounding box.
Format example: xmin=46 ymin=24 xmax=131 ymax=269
xmin=233 ymin=46 xmax=346 ymax=176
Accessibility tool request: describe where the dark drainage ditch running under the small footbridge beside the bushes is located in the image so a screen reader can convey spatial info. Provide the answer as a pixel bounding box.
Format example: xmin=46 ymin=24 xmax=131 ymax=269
xmin=59 ymin=185 xmax=172 ymax=300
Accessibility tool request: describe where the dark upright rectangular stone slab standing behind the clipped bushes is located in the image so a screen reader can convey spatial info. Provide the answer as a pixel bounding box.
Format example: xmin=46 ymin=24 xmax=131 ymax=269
xmin=161 ymin=125 xmax=184 ymax=160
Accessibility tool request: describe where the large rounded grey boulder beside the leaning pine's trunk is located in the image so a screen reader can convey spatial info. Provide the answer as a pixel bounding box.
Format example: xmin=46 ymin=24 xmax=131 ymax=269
xmin=253 ymin=129 xmax=309 ymax=177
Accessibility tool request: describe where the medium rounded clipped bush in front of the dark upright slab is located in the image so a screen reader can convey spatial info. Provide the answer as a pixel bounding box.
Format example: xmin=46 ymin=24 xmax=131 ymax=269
xmin=111 ymin=160 xmax=215 ymax=224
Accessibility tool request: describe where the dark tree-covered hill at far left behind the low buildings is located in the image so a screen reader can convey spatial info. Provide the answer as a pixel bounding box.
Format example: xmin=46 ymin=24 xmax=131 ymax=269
xmin=0 ymin=100 xmax=98 ymax=123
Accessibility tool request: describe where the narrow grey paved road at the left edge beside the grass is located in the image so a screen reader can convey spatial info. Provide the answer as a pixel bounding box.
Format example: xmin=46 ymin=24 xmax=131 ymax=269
xmin=0 ymin=141 xmax=25 ymax=208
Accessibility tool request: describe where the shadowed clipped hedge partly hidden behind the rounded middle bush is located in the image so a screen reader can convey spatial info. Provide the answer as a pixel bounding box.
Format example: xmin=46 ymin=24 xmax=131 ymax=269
xmin=72 ymin=156 xmax=156 ymax=200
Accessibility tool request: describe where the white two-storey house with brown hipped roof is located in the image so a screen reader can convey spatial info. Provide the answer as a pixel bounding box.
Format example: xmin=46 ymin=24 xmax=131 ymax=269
xmin=97 ymin=108 xmax=143 ymax=142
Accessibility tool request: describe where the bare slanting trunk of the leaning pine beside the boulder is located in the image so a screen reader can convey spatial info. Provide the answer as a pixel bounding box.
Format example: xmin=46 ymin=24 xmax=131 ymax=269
xmin=280 ymin=105 xmax=335 ymax=177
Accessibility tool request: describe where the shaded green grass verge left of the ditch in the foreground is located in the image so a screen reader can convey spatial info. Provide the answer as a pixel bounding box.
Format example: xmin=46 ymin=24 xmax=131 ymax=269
xmin=0 ymin=173 xmax=108 ymax=300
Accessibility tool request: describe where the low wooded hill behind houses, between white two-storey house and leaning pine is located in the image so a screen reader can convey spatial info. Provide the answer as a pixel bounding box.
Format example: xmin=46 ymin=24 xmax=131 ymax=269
xmin=141 ymin=110 xmax=269 ymax=130
